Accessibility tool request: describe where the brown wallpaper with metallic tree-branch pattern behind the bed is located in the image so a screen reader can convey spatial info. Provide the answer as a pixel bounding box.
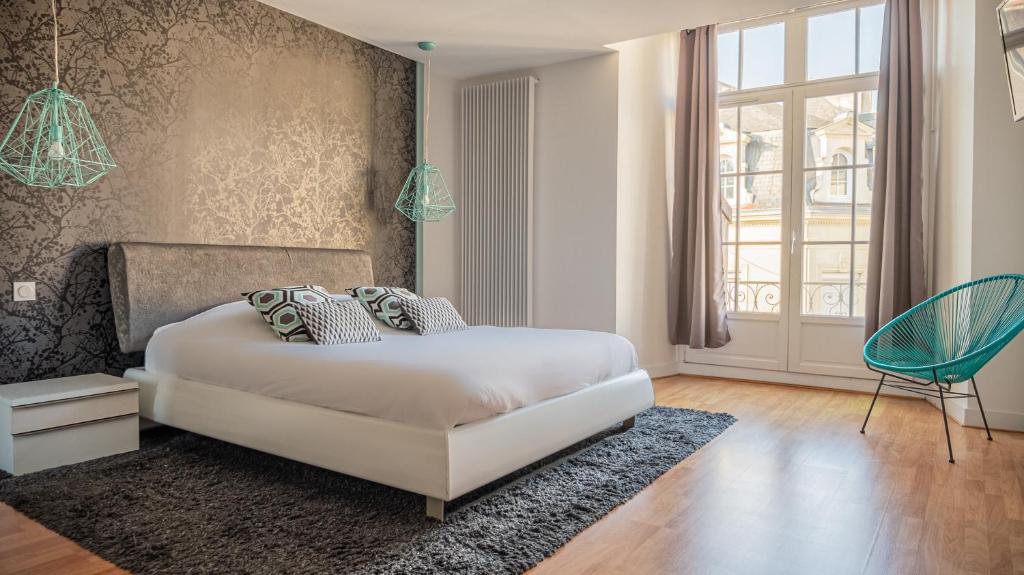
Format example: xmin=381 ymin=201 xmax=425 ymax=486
xmin=0 ymin=0 xmax=416 ymax=383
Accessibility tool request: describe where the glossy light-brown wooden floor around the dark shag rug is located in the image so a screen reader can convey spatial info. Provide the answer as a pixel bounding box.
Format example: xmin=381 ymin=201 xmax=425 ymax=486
xmin=0 ymin=377 xmax=1024 ymax=575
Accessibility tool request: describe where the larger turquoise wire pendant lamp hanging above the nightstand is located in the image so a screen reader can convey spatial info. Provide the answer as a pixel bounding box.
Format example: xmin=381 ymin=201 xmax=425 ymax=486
xmin=0 ymin=0 xmax=117 ymax=187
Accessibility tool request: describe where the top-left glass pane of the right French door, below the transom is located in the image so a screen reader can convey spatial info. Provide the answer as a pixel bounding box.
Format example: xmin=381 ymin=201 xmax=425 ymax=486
xmin=804 ymin=94 xmax=854 ymax=168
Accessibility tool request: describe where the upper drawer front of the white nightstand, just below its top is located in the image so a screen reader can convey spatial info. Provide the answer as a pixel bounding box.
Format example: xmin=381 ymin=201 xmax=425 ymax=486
xmin=9 ymin=390 xmax=138 ymax=435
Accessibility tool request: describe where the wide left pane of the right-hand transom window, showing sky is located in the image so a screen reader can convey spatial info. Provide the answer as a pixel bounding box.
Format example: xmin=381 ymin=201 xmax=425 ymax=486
xmin=807 ymin=10 xmax=857 ymax=80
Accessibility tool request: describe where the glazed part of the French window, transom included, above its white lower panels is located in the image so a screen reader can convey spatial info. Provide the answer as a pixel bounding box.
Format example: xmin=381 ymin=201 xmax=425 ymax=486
xmin=718 ymin=0 xmax=884 ymax=317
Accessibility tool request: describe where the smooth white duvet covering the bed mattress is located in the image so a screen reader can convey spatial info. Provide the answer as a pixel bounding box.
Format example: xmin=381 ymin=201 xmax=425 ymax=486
xmin=145 ymin=302 xmax=637 ymax=429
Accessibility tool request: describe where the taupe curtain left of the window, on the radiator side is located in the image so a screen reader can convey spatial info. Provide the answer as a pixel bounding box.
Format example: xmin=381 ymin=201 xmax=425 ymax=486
xmin=669 ymin=26 xmax=729 ymax=349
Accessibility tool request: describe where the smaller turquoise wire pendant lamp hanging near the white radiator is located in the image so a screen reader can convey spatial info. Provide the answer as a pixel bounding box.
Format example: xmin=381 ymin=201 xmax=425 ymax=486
xmin=394 ymin=42 xmax=455 ymax=222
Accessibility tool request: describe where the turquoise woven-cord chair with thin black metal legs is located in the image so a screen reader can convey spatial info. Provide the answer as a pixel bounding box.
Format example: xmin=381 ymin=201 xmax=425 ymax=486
xmin=860 ymin=274 xmax=1024 ymax=463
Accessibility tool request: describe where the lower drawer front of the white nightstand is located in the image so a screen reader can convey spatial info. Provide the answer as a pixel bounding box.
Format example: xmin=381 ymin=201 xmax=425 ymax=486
xmin=7 ymin=414 xmax=138 ymax=475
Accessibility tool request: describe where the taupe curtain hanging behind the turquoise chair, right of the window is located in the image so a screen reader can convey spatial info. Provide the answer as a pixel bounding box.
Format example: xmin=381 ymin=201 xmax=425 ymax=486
xmin=864 ymin=0 xmax=927 ymax=337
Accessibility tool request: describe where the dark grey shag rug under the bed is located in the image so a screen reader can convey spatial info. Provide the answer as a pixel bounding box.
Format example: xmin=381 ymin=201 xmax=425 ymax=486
xmin=0 ymin=407 xmax=736 ymax=574
